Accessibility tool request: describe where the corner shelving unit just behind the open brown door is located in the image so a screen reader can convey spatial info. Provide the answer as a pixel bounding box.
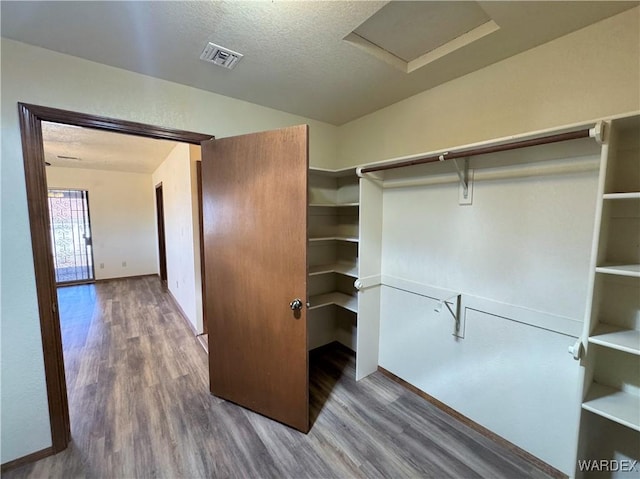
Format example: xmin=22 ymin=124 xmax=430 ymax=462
xmin=308 ymin=168 xmax=360 ymax=350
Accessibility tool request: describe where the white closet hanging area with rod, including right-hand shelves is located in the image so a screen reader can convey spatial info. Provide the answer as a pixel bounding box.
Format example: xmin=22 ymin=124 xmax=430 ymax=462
xmin=348 ymin=114 xmax=640 ymax=477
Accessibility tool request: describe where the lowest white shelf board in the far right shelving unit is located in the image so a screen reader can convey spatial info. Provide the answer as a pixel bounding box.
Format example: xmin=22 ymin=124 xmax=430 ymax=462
xmin=582 ymin=383 xmax=640 ymax=431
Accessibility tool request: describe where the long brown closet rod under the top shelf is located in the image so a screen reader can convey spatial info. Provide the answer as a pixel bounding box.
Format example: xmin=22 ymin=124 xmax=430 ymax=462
xmin=360 ymin=128 xmax=591 ymax=173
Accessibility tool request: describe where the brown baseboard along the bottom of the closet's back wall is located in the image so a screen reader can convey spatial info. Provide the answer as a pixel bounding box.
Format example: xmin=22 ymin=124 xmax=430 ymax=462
xmin=378 ymin=366 xmax=569 ymax=479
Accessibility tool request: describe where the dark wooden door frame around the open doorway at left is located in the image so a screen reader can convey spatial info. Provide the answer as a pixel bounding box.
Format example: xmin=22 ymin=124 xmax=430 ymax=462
xmin=18 ymin=103 xmax=213 ymax=454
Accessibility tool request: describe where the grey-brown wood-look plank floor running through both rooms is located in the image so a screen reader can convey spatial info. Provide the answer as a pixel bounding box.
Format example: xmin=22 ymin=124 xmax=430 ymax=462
xmin=3 ymin=277 xmax=548 ymax=479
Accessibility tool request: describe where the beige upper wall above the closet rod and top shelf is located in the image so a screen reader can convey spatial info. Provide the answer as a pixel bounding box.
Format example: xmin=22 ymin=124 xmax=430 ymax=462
xmin=338 ymin=8 xmax=640 ymax=167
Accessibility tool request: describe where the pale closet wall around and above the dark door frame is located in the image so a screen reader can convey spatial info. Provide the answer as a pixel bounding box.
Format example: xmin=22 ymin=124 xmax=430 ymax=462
xmin=0 ymin=38 xmax=337 ymax=463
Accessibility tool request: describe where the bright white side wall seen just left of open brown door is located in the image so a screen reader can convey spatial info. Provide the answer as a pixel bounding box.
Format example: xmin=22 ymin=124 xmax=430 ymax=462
xmin=149 ymin=143 xmax=202 ymax=333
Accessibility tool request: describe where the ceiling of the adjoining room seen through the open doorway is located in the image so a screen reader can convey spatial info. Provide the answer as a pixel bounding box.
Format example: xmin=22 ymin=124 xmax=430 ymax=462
xmin=42 ymin=122 xmax=177 ymax=173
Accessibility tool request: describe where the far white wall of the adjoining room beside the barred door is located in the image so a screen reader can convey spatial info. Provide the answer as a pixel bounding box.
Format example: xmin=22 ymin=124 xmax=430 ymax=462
xmin=47 ymin=167 xmax=158 ymax=279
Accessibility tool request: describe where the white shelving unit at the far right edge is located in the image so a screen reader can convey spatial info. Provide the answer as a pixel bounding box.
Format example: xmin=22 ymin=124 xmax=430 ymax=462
xmin=576 ymin=116 xmax=640 ymax=477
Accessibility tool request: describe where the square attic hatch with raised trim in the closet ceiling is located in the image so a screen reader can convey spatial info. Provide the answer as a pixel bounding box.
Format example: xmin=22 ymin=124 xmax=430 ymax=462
xmin=344 ymin=1 xmax=500 ymax=73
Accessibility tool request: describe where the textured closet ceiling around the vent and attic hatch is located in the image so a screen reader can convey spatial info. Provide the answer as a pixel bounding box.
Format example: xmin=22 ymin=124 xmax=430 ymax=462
xmin=0 ymin=0 xmax=638 ymax=125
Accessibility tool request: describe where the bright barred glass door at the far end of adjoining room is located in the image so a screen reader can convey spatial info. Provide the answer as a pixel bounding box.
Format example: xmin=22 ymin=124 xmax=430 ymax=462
xmin=48 ymin=189 xmax=95 ymax=285
